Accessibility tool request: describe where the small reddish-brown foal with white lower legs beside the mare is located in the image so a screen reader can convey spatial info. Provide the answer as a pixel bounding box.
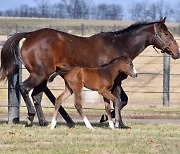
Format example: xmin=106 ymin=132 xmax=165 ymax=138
xmin=50 ymin=57 xmax=137 ymax=129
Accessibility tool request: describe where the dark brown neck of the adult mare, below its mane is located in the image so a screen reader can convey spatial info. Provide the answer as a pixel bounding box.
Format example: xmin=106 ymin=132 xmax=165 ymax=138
xmin=114 ymin=24 xmax=154 ymax=59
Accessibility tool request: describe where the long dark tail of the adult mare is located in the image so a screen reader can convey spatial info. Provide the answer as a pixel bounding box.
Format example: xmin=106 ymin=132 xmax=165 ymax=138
xmin=0 ymin=32 xmax=29 ymax=81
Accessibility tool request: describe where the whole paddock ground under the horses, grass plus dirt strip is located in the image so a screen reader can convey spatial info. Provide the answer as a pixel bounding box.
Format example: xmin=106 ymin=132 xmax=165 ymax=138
xmin=0 ymin=108 xmax=180 ymax=154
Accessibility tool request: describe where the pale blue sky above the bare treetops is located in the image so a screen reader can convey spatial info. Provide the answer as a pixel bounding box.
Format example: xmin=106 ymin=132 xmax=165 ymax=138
xmin=0 ymin=0 xmax=179 ymax=10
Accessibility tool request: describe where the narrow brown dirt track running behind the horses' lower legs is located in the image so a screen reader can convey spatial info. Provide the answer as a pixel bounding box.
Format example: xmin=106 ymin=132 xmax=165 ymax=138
xmin=0 ymin=112 xmax=180 ymax=125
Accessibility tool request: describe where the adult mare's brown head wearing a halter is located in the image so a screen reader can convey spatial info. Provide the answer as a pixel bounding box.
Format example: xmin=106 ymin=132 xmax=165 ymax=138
xmin=153 ymin=18 xmax=180 ymax=59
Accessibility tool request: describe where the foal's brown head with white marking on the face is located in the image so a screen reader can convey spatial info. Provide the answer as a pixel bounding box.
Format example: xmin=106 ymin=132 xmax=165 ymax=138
xmin=121 ymin=58 xmax=137 ymax=78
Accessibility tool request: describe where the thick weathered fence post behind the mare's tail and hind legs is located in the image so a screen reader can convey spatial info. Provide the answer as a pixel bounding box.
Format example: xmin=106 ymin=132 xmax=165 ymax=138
xmin=8 ymin=46 xmax=22 ymax=124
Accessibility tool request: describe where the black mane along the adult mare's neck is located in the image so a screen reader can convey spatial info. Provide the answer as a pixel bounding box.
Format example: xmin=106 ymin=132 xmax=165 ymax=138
xmin=106 ymin=21 xmax=160 ymax=36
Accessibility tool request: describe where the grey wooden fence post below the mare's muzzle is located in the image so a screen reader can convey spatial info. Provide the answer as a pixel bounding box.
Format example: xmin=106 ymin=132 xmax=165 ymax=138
xmin=163 ymin=53 xmax=170 ymax=106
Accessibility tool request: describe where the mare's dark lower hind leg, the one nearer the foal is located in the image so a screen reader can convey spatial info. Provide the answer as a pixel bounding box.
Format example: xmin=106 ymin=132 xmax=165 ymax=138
xmin=31 ymin=81 xmax=48 ymax=126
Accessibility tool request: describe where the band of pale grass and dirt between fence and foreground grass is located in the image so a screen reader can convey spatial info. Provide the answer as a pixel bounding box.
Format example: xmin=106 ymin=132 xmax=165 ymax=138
xmin=0 ymin=107 xmax=180 ymax=125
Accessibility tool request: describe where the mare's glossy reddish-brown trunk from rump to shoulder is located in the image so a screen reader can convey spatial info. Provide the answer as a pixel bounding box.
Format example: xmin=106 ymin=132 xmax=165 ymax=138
xmin=21 ymin=28 xmax=118 ymax=76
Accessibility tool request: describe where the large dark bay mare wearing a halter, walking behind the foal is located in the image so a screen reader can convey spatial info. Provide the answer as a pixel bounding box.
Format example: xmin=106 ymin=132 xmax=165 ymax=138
xmin=0 ymin=18 xmax=180 ymax=128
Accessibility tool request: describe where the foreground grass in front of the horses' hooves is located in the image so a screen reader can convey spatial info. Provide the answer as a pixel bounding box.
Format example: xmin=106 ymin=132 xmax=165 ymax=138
xmin=0 ymin=123 xmax=180 ymax=154
